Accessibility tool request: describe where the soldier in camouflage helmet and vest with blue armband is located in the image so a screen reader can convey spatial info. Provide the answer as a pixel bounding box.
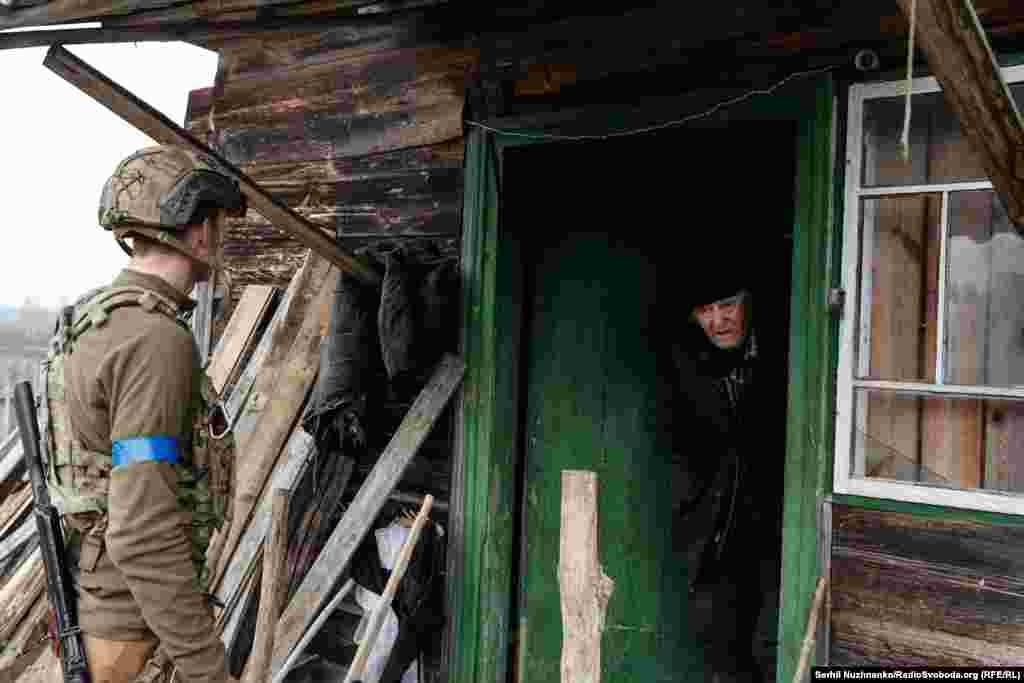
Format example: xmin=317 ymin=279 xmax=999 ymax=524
xmin=43 ymin=146 xmax=245 ymax=683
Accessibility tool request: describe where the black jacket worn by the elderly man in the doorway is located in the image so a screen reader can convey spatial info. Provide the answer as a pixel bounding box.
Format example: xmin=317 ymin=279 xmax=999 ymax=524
xmin=670 ymin=324 xmax=784 ymax=586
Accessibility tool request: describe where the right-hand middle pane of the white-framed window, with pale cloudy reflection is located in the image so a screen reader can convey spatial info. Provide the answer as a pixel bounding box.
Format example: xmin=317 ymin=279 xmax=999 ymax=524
xmin=944 ymin=190 xmax=1024 ymax=386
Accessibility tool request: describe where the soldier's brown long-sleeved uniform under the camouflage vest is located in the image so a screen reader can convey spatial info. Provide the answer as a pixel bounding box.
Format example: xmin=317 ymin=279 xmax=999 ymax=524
xmin=66 ymin=269 xmax=227 ymax=683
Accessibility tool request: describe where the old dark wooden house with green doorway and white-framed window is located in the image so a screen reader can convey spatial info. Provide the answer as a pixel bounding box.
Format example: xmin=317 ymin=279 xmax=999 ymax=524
xmin=0 ymin=0 xmax=1024 ymax=683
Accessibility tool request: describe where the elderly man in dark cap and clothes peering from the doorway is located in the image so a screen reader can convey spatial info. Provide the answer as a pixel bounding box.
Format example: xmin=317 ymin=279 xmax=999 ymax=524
xmin=672 ymin=267 xmax=783 ymax=683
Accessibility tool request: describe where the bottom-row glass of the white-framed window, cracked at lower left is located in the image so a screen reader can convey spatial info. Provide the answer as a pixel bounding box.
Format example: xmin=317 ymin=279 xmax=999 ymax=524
xmin=851 ymin=389 xmax=1024 ymax=493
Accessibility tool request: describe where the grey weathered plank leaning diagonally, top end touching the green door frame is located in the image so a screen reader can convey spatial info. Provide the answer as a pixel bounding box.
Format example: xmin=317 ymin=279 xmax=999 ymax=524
xmin=270 ymin=355 xmax=465 ymax=675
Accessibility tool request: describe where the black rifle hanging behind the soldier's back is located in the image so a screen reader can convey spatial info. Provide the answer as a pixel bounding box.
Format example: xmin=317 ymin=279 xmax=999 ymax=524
xmin=14 ymin=382 xmax=89 ymax=683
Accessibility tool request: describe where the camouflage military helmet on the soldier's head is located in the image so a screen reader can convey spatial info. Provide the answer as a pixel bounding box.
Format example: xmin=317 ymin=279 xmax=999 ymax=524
xmin=98 ymin=145 xmax=246 ymax=257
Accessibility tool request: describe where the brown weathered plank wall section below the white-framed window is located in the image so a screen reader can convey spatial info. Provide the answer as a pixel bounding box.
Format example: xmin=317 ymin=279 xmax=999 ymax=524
xmin=829 ymin=506 xmax=1024 ymax=666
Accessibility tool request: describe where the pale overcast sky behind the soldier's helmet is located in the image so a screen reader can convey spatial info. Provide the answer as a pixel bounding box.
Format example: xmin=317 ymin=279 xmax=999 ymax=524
xmin=0 ymin=38 xmax=217 ymax=307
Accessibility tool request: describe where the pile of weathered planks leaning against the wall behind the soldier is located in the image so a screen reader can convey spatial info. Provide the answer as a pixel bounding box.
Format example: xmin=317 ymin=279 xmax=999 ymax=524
xmin=0 ymin=252 xmax=464 ymax=683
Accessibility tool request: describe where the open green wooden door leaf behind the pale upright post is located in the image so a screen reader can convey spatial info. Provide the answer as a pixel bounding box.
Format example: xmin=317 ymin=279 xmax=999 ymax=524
xmin=506 ymin=140 xmax=701 ymax=683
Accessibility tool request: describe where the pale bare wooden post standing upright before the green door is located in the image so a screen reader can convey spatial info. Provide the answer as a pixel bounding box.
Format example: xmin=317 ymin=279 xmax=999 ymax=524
xmin=558 ymin=470 xmax=614 ymax=683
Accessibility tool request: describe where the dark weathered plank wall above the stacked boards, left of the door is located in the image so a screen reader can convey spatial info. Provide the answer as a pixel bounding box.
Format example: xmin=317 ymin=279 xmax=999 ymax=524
xmin=187 ymin=16 xmax=475 ymax=321
